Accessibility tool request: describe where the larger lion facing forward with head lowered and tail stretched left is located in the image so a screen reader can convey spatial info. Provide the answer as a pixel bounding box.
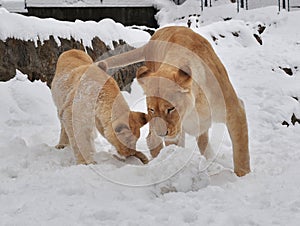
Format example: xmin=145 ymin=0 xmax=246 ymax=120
xmin=97 ymin=26 xmax=250 ymax=176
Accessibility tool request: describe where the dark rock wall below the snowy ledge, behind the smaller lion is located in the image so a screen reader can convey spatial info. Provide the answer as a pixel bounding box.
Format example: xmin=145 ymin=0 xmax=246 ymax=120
xmin=0 ymin=36 xmax=139 ymax=91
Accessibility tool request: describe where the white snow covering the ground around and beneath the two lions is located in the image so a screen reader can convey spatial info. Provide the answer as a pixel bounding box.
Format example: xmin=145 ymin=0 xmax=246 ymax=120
xmin=0 ymin=2 xmax=300 ymax=226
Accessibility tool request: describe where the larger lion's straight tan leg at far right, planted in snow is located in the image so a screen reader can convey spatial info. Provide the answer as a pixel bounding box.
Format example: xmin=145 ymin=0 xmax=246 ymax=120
xmin=226 ymin=102 xmax=250 ymax=176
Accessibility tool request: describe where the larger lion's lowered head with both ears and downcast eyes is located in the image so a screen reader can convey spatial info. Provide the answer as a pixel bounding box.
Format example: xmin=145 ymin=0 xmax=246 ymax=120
xmin=137 ymin=65 xmax=195 ymax=139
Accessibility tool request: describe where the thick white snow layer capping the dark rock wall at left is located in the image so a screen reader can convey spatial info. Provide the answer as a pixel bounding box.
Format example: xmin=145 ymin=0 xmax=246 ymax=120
xmin=0 ymin=8 xmax=150 ymax=48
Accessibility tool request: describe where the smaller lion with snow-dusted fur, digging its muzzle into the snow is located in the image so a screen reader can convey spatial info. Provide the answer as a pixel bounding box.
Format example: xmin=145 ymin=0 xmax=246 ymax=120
xmin=51 ymin=49 xmax=148 ymax=164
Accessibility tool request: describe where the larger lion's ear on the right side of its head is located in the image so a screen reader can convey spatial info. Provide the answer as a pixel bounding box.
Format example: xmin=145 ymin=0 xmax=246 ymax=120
xmin=175 ymin=65 xmax=193 ymax=92
